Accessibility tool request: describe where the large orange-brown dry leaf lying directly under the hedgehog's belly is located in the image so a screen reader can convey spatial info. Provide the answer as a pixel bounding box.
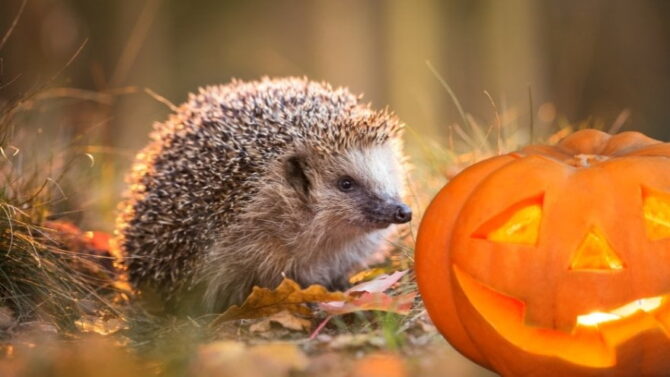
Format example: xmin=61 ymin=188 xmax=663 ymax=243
xmin=213 ymin=278 xmax=347 ymax=325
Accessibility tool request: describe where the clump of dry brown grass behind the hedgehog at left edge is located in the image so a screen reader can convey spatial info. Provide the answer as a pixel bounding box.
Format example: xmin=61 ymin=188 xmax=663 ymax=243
xmin=0 ymin=97 xmax=123 ymax=334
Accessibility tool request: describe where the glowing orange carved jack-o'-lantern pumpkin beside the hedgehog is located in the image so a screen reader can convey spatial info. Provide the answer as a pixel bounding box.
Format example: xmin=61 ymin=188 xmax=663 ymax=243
xmin=415 ymin=130 xmax=670 ymax=376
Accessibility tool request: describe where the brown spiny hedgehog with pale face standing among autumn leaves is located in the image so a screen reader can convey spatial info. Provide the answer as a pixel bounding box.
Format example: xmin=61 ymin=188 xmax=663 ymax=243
xmin=116 ymin=77 xmax=412 ymax=312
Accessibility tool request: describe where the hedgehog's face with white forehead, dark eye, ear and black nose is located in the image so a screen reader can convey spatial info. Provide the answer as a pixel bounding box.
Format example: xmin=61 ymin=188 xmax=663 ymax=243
xmin=287 ymin=144 xmax=412 ymax=232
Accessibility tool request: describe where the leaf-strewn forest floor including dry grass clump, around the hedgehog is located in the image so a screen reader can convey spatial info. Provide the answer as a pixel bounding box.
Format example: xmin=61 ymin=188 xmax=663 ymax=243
xmin=0 ymin=92 xmax=504 ymax=377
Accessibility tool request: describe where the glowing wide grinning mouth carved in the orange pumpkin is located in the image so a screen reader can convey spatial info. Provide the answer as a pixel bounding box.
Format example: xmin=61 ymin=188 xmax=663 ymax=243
xmin=453 ymin=265 xmax=670 ymax=368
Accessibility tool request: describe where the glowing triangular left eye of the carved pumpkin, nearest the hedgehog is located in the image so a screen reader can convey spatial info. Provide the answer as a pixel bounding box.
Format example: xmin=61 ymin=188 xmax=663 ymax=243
xmin=472 ymin=195 xmax=544 ymax=245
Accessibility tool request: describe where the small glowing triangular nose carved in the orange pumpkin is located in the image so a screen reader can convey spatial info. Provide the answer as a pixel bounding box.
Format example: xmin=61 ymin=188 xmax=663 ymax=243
xmin=570 ymin=228 xmax=624 ymax=271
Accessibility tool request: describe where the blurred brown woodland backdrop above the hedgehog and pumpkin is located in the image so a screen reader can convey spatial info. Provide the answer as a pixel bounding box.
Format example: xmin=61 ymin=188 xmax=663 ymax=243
xmin=0 ymin=0 xmax=670 ymax=223
